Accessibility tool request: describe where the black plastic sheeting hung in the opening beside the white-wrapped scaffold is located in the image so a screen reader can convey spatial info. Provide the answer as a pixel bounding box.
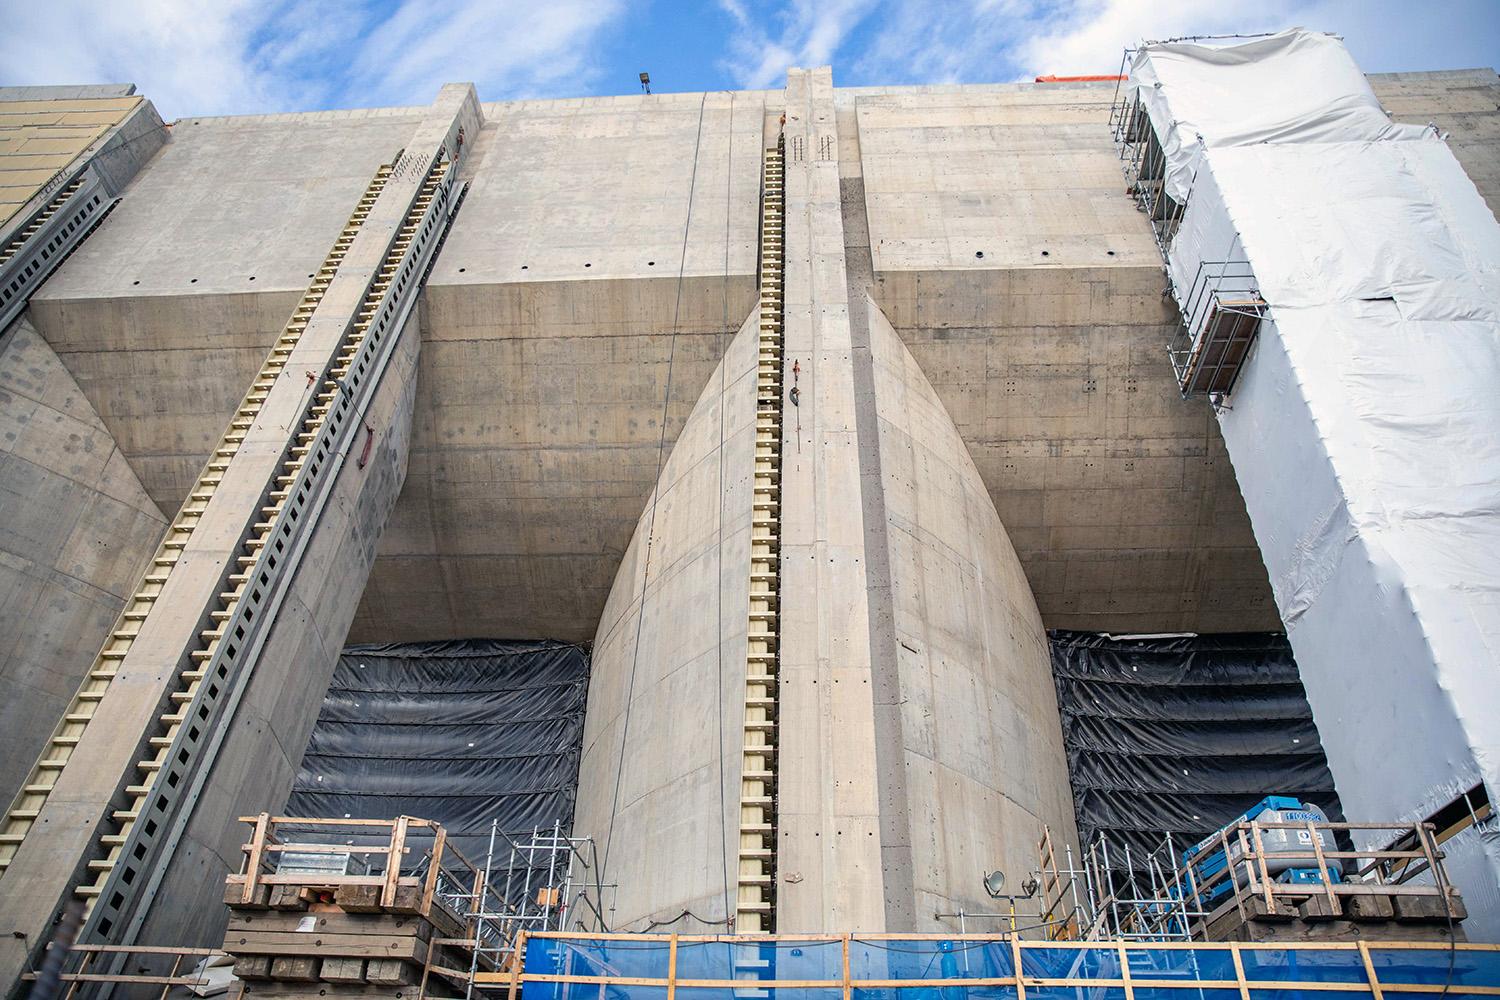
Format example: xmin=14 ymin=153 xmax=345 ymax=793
xmin=1050 ymin=630 xmax=1343 ymax=852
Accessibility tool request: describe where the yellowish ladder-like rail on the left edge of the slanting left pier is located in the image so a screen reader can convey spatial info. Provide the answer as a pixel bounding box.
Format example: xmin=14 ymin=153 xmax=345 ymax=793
xmin=0 ymin=165 xmax=392 ymax=879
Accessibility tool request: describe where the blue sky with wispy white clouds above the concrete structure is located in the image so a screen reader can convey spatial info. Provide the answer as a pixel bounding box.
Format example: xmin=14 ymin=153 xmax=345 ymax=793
xmin=0 ymin=0 xmax=1500 ymax=120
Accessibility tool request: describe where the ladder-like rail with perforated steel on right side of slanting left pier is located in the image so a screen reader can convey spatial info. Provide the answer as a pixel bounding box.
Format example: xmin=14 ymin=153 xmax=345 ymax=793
xmin=77 ymin=156 xmax=455 ymax=945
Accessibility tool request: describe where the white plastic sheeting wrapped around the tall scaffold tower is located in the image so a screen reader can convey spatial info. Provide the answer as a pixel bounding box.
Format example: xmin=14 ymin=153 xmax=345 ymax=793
xmin=1131 ymin=31 xmax=1500 ymax=937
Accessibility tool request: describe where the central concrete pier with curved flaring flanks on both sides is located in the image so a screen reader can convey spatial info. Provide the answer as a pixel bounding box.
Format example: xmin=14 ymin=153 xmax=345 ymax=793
xmin=575 ymin=69 xmax=1077 ymax=933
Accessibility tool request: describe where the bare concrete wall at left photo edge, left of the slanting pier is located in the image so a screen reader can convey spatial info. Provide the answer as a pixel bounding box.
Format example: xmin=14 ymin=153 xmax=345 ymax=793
xmin=0 ymin=318 xmax=167 ymax=804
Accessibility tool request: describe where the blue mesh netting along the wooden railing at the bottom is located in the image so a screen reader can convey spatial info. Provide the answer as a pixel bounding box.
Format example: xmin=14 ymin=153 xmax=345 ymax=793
xmin=525 ymin=937 xmax=1500 ymax=1000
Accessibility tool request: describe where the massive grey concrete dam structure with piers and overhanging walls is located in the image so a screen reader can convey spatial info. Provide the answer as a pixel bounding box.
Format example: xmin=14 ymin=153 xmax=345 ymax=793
xmin=0 ymin=44 xmax=1500 ymax=981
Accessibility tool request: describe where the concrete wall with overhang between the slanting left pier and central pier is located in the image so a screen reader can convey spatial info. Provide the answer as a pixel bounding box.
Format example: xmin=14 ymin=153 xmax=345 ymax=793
xmin=354 ymin=93 xmax=767 ymax=642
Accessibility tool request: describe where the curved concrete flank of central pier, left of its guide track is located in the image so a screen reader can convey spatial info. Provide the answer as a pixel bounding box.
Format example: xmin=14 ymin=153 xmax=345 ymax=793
xmin=573 ymin=310 xmax=758 ymax=933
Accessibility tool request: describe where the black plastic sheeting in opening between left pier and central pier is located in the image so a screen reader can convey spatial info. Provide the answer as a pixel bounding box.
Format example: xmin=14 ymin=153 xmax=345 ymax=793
xmin=287 ymin=639 xmax=590 ymax=862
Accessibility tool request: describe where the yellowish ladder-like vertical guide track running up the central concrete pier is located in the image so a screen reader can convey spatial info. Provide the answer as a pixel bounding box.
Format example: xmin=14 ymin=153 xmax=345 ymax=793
xmin=735 ymin=138 xmax=786 ymax=934
